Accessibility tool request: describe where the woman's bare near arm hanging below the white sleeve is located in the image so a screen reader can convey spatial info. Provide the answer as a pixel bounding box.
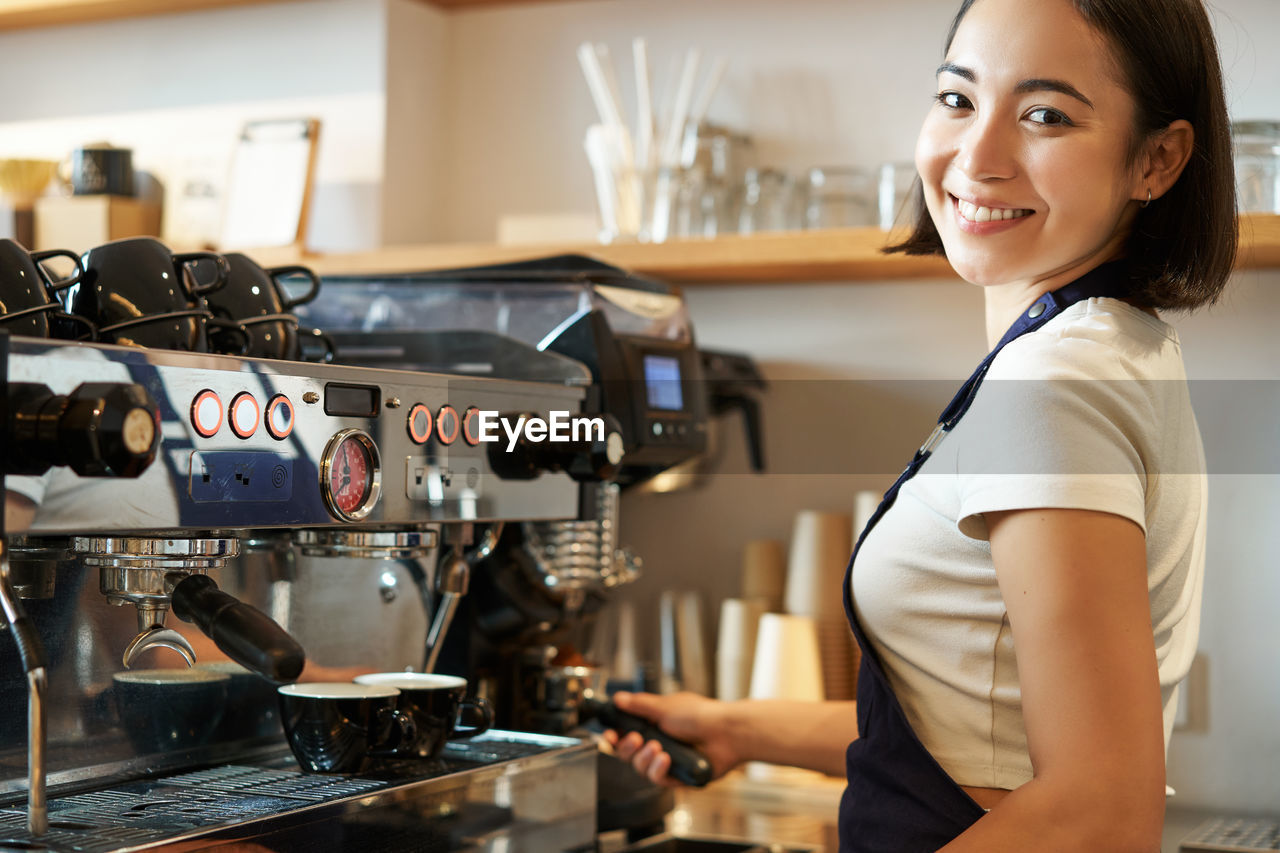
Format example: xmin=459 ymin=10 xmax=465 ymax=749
xmin=943 ymin=510 xmax=1165 ymax=853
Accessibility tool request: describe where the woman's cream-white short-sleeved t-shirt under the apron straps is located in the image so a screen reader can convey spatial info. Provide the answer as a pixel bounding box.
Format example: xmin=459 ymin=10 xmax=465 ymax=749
xmin=852 ymin=298 xmax=1207 ymax=789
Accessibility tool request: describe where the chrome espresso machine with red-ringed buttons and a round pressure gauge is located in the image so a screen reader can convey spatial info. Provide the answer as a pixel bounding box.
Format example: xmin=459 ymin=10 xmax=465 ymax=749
xmin=0 ymin=302 xmax=627 ymax=852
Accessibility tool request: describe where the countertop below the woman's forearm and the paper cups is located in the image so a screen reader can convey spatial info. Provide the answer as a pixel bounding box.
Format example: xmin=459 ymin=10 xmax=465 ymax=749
xmin=634 ymin=766 xmax=1254 ymax=853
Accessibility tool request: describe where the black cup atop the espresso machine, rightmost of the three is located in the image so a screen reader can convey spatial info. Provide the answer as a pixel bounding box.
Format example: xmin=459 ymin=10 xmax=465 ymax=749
xmin=207 ymin=252 xmax=334 ymax=361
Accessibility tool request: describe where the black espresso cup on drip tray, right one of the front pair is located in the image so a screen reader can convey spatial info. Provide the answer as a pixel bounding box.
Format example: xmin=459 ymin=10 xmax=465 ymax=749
xmin=356 ymin=672 xmax=493 ymax=758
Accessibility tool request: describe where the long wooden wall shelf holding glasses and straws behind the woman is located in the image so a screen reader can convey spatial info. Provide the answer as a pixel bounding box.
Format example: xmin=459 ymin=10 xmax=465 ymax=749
xmin=267 ymin=214 xmax=1280 ymax=284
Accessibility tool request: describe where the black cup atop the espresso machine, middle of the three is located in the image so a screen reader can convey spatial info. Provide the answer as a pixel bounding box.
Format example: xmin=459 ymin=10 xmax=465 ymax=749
xmin=68 ymin=237 xmax=247 ymax=352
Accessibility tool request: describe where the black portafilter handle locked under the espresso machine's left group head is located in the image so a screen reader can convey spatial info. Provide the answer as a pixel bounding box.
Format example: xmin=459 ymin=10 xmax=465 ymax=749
xmin=169 ymin=575 xmax=307 ymax=684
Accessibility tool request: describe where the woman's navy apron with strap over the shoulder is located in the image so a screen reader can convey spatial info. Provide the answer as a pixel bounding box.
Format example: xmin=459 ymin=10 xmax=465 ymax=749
xmin=840 ymin=261 xmax=1130 ymax=853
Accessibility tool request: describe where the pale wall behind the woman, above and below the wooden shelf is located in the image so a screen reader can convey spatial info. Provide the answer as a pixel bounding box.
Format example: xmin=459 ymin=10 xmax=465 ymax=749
xmin=0 ymin=0 xmax=1280 ymax=811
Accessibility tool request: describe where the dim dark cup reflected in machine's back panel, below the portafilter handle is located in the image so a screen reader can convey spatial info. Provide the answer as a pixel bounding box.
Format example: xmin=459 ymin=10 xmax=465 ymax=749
xmin=111 ymin=669 xmax=230 ymax=754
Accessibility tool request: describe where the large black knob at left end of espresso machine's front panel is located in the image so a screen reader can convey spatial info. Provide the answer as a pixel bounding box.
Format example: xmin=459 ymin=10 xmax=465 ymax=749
xmin=5 ymin=382 xmax=160 ymax=476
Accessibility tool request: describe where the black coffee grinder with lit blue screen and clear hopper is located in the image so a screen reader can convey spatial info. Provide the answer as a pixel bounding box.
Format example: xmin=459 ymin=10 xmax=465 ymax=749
xmin=300 ymin=256 xmax=763 ymax=839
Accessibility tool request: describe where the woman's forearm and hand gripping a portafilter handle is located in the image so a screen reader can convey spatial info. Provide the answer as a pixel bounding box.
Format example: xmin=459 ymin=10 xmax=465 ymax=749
xmin=608 ymin=693 xmax=858 ymax=784
